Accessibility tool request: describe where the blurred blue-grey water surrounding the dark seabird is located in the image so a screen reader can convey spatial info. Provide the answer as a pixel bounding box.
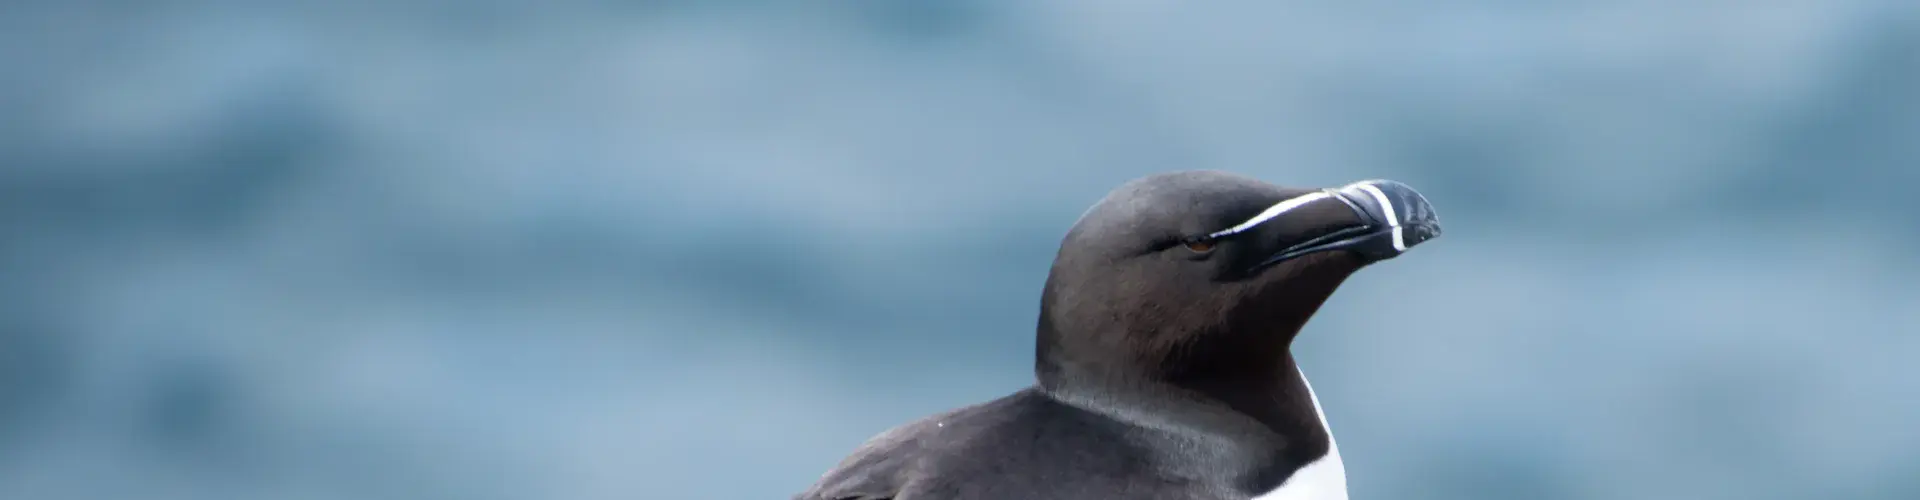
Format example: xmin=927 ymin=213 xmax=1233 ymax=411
xmin=0 ymin=0 xmax=1920 ymax=500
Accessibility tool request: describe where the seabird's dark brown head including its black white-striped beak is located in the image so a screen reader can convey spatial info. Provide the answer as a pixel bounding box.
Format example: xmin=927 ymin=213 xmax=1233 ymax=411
xmin=1035 ymin=171 xmax=1440 ymax=388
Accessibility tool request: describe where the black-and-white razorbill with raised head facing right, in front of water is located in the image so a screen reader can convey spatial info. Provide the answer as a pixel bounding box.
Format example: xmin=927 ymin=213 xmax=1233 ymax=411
xmin=793 ymin=169 xmax=1440 ymax=500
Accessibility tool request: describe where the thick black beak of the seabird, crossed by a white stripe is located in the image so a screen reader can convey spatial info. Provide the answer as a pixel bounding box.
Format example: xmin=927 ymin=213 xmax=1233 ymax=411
xmin=1256 ymin=179 xmax=1440 ymax=267
